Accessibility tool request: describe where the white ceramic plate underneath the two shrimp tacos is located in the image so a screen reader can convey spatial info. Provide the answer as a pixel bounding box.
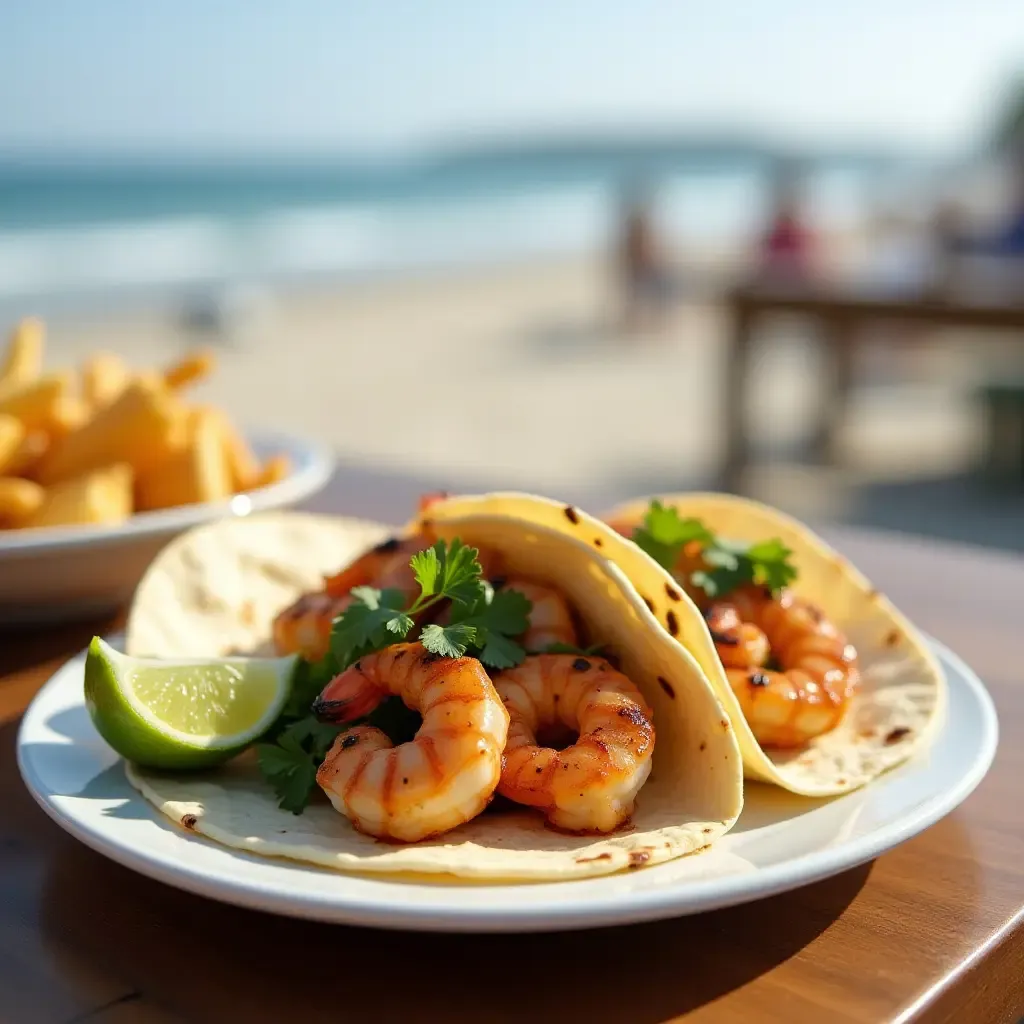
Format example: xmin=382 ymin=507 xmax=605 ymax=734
xmin=17 ymin=643 xmax=998 ymax=932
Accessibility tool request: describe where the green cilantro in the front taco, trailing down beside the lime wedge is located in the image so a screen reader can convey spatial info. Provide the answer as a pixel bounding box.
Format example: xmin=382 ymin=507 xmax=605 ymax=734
xmin=257 ymin=539 xmax=531 ymax=814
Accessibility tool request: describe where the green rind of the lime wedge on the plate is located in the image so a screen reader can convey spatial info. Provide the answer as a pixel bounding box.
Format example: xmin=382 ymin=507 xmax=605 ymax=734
xmin=84 ymin=637 xmax=298 ymax=770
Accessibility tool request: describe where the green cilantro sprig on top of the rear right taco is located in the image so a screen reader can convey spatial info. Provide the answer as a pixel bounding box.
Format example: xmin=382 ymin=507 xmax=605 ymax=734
xmin=633 ymin=500 xmax=797 ymax=599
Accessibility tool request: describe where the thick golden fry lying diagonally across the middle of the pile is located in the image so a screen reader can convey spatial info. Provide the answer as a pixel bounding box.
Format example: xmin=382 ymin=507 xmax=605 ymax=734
xmin=34 ymin=380 xmax=188 ymax=484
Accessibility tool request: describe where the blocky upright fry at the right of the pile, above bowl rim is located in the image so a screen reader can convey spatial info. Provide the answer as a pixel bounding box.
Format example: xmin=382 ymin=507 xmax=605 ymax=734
xmin=135 ymin=407 xmax=232 ymax=511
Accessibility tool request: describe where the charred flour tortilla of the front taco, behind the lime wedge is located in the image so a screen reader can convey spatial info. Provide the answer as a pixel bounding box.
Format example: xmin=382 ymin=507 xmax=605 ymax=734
xmin=121 ymin=502 xmax=742 ymax=881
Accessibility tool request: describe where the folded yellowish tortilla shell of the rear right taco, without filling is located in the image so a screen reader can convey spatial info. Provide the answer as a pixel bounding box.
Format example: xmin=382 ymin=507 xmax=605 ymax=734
xmin=605 ymin=493 xmax=946 ymax=796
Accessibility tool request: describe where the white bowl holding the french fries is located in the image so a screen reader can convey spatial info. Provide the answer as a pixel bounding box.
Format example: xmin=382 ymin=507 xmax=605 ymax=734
xmin=0 ymin=425 xmax=334 ymax=626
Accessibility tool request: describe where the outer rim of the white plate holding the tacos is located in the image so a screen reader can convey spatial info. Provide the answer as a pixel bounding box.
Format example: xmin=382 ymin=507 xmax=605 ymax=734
xmin=16 ymin=634 xmax=999 ymax=934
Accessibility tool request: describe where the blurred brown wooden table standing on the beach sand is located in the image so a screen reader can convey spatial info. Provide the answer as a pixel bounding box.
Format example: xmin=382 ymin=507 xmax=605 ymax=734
xmin=721 ymin=281 xmax=1024 ymax=490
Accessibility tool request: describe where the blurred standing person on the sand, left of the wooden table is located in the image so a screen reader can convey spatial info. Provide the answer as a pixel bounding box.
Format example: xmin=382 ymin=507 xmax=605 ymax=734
xmin=615 ymin=178 xmax=675 ymax=335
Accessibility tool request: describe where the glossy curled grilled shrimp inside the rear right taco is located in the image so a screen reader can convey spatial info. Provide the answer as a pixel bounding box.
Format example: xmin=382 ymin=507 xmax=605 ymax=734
xmin=705 ymin=588 xmax=860 ymax=748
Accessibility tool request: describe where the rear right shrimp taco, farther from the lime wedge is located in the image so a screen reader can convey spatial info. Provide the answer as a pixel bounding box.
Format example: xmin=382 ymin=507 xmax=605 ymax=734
xmin=607 ymin=494 xmax=945 ymax=796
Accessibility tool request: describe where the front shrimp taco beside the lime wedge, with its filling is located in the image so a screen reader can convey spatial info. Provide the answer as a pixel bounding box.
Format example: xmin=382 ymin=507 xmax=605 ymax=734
xmin=117 ymin=496 xmax=742 ymax=881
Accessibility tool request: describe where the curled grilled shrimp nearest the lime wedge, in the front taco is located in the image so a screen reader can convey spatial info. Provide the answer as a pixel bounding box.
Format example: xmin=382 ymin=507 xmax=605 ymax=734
xmin=313 ymin=643 xmax=509 ymax=843
